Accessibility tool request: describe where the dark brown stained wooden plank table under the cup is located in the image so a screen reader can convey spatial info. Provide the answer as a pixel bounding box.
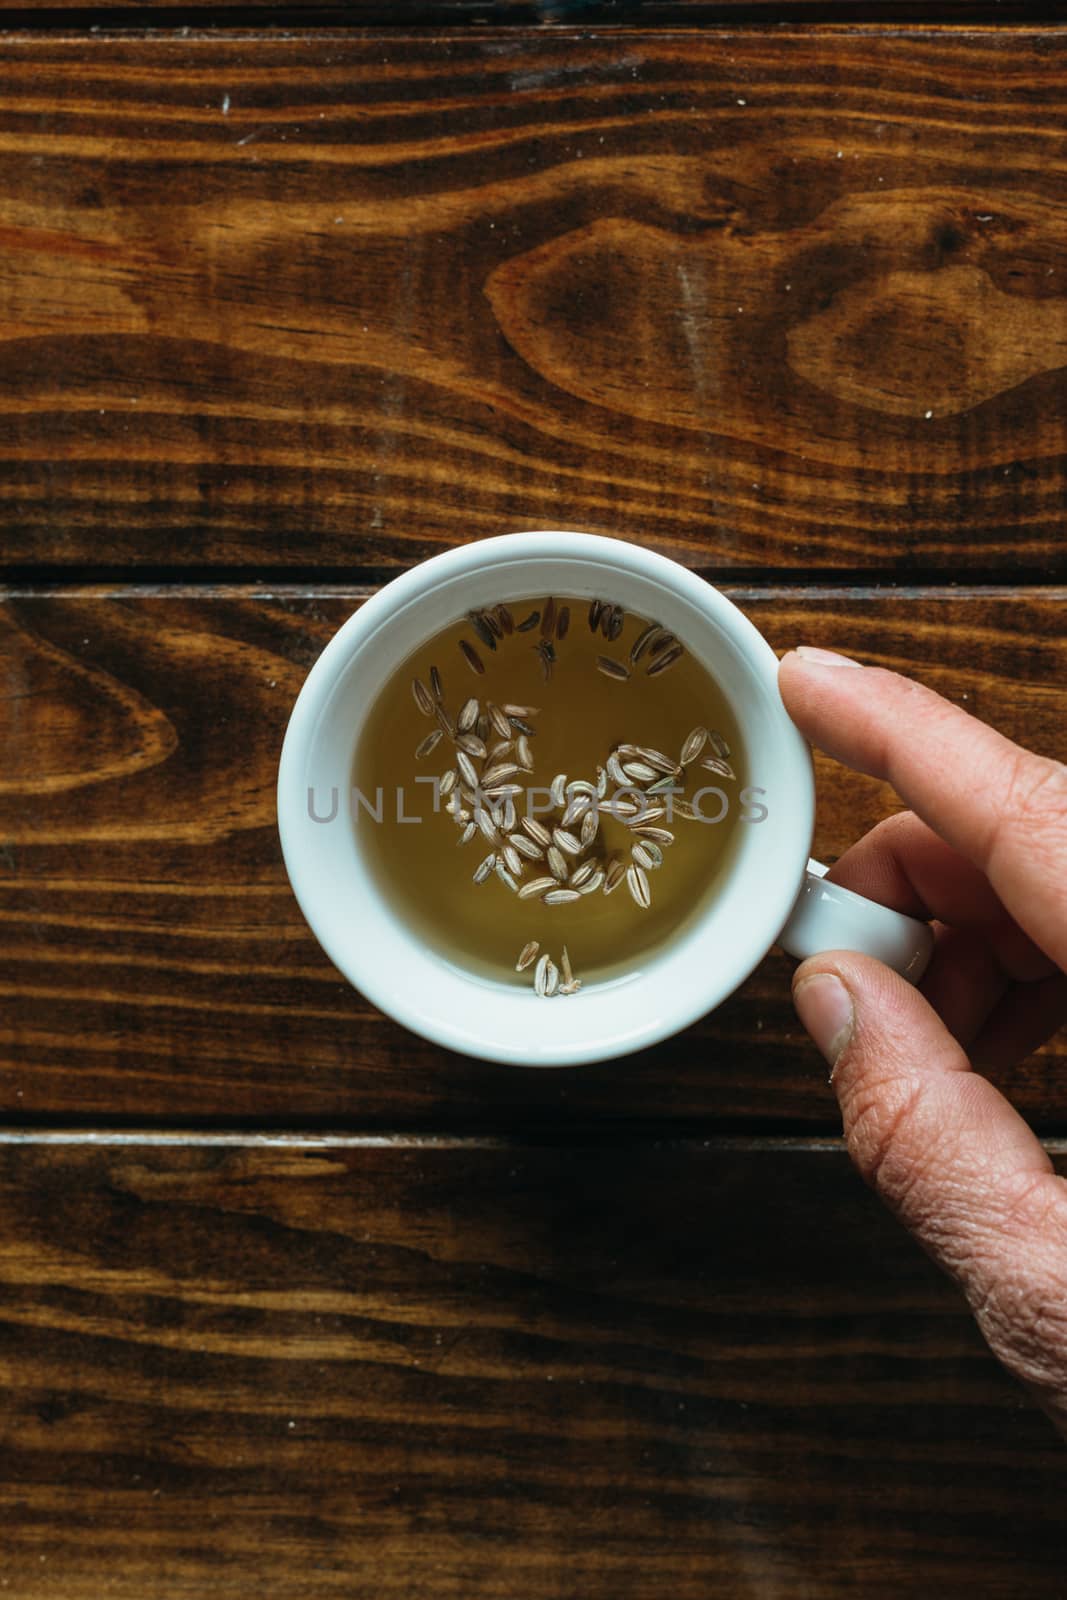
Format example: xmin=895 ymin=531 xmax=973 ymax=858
xmin=0 ymin=0 xmax=1067 ymax=1600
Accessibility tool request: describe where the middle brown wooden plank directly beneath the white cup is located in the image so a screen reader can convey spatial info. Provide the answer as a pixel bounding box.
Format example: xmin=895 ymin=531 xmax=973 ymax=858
xmin=0 ymin=589 xmax=1067 ymax=1130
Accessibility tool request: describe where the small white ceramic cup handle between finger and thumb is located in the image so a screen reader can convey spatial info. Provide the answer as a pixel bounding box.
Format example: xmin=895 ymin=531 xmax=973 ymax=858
xmin=777 ymin=861 xmax=934 ymax=984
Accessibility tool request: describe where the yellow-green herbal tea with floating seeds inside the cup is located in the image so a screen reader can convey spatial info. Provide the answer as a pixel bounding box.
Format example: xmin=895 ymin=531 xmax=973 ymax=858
xmin=352 ymin=597 xmax=758 ymax=997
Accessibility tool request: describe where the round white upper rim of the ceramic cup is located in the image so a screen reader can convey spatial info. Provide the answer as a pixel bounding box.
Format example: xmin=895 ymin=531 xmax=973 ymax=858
xmin=277 ymin=530 xmax=814 ymax=1066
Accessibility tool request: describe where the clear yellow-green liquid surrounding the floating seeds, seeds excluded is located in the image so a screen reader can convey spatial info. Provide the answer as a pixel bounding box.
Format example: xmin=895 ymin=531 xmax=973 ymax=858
xmin=352 ymin=597 xmax=749 ymax=986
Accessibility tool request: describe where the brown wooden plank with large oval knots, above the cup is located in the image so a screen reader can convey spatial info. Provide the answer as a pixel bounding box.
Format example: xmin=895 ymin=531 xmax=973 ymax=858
xmin=0 ymin=27 xmax=1067 ymax=576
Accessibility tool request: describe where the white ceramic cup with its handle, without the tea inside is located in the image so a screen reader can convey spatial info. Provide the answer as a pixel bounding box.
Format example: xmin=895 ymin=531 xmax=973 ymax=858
xmin=278 ymin=533 xmax=933 ymax=1067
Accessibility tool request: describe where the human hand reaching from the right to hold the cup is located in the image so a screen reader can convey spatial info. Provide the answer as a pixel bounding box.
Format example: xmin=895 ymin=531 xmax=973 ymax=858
xmin=779 ymin=650 xmax=1067 ymax=1437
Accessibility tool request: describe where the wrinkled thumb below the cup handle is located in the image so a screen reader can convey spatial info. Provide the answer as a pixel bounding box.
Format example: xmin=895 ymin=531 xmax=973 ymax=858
xmin=793 ymin=950 xmax=1067 ymax=1434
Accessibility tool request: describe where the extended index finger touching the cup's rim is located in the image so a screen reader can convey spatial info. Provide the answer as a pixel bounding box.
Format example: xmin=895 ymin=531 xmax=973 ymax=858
xmin=779 ymin=651 xmax=1067 ymax=966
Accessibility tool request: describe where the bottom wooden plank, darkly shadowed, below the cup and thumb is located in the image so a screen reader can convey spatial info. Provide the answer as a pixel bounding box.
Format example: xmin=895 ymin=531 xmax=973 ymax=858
xmin=0 ymin=1136 xmax=1067 ymax=1600
